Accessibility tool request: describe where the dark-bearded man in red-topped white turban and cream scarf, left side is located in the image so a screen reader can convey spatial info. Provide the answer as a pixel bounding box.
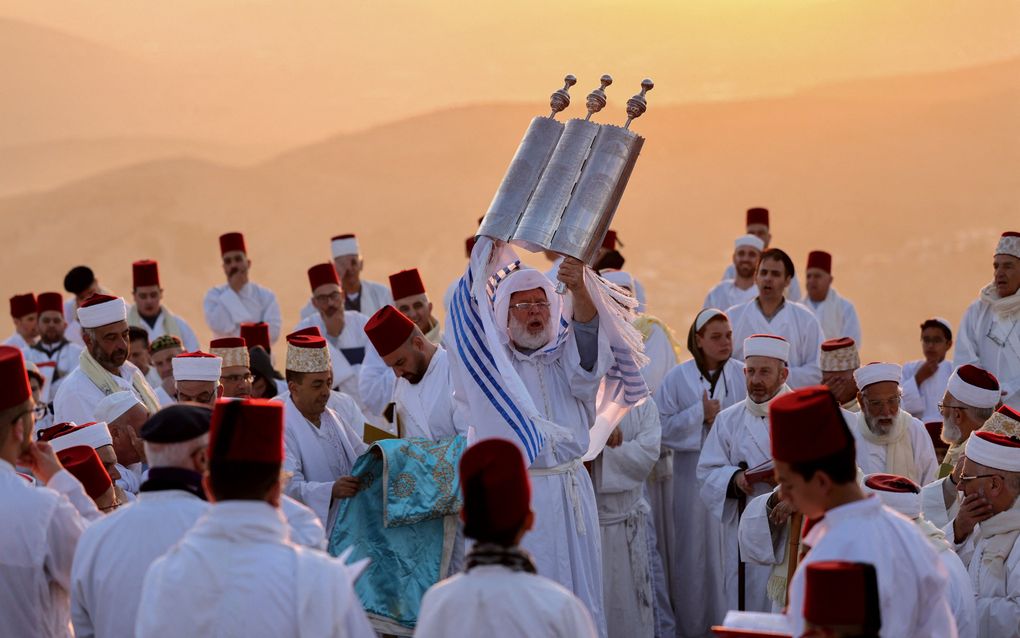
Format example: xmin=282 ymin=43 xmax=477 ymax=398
xmin=53 ymin=295 xmax=159 ymax=423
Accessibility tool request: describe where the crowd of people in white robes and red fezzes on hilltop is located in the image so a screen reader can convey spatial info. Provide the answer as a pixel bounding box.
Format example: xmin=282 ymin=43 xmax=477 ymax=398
xmin=0 ymin=208 xmax=1020 ymax=638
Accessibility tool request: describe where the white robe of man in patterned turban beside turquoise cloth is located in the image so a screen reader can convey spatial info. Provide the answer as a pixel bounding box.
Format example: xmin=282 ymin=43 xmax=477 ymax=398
xmin=284 ymin=396 xmax=368 ymax=530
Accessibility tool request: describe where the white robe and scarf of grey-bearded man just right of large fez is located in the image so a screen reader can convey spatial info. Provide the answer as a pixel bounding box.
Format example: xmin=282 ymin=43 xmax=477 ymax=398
xmin=848 ymin=409 xmax=938 ymax=486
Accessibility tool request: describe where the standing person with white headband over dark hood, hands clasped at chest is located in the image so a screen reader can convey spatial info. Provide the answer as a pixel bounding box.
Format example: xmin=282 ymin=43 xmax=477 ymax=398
xmin=655 ymin=308 xmax=747 ymax=637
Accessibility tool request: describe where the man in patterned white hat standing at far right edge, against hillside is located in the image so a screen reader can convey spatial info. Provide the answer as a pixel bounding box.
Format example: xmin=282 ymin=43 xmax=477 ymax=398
xmin=953 ymin=232 xmax=1020 ymax=408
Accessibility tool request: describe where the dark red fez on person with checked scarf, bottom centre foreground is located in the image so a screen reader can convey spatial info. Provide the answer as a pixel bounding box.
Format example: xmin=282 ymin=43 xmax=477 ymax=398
xmin=460 ymin=439 xmax=531 ymax=541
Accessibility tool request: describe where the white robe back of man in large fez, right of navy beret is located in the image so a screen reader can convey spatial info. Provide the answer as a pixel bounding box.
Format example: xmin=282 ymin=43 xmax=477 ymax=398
xmin=136 ymin=500 xmax=375 ymax=638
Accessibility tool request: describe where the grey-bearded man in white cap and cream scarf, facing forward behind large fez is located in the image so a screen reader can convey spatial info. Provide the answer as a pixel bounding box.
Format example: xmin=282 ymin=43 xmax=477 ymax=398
xmin=851 ymin=363 xmax=938 ymax=486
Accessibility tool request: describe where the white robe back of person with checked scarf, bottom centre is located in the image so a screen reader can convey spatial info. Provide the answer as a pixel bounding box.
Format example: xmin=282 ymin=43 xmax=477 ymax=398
xmin=414 ymin=563 xmax=598 ymax=638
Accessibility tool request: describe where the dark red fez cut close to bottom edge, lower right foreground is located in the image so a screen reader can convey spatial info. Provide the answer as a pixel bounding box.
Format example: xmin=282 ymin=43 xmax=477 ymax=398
xmin=804 ymin=560 xmax=881 ymax=632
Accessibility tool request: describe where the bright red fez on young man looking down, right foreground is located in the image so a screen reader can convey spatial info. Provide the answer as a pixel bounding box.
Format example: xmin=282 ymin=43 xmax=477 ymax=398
xmin=768 ymin=386 xmax=853 ymax=463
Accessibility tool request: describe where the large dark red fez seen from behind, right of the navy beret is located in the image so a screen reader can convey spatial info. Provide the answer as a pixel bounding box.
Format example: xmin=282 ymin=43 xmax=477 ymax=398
xmin=209 ymin=399 xmax=284 ymax=463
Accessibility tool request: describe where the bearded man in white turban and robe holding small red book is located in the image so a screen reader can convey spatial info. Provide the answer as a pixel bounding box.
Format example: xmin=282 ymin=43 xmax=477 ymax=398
xmin=698 ymin=335 xmax=789 ymax=612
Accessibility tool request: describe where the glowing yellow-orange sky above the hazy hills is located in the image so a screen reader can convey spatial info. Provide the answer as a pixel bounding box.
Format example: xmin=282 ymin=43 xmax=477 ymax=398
xmin=0 ymin=0 xmax=1020 ymax=144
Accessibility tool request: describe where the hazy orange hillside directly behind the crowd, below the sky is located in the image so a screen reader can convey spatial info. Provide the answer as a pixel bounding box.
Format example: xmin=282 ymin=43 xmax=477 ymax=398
xmin=0 ymin=60 xmax=1020 ymax=359
